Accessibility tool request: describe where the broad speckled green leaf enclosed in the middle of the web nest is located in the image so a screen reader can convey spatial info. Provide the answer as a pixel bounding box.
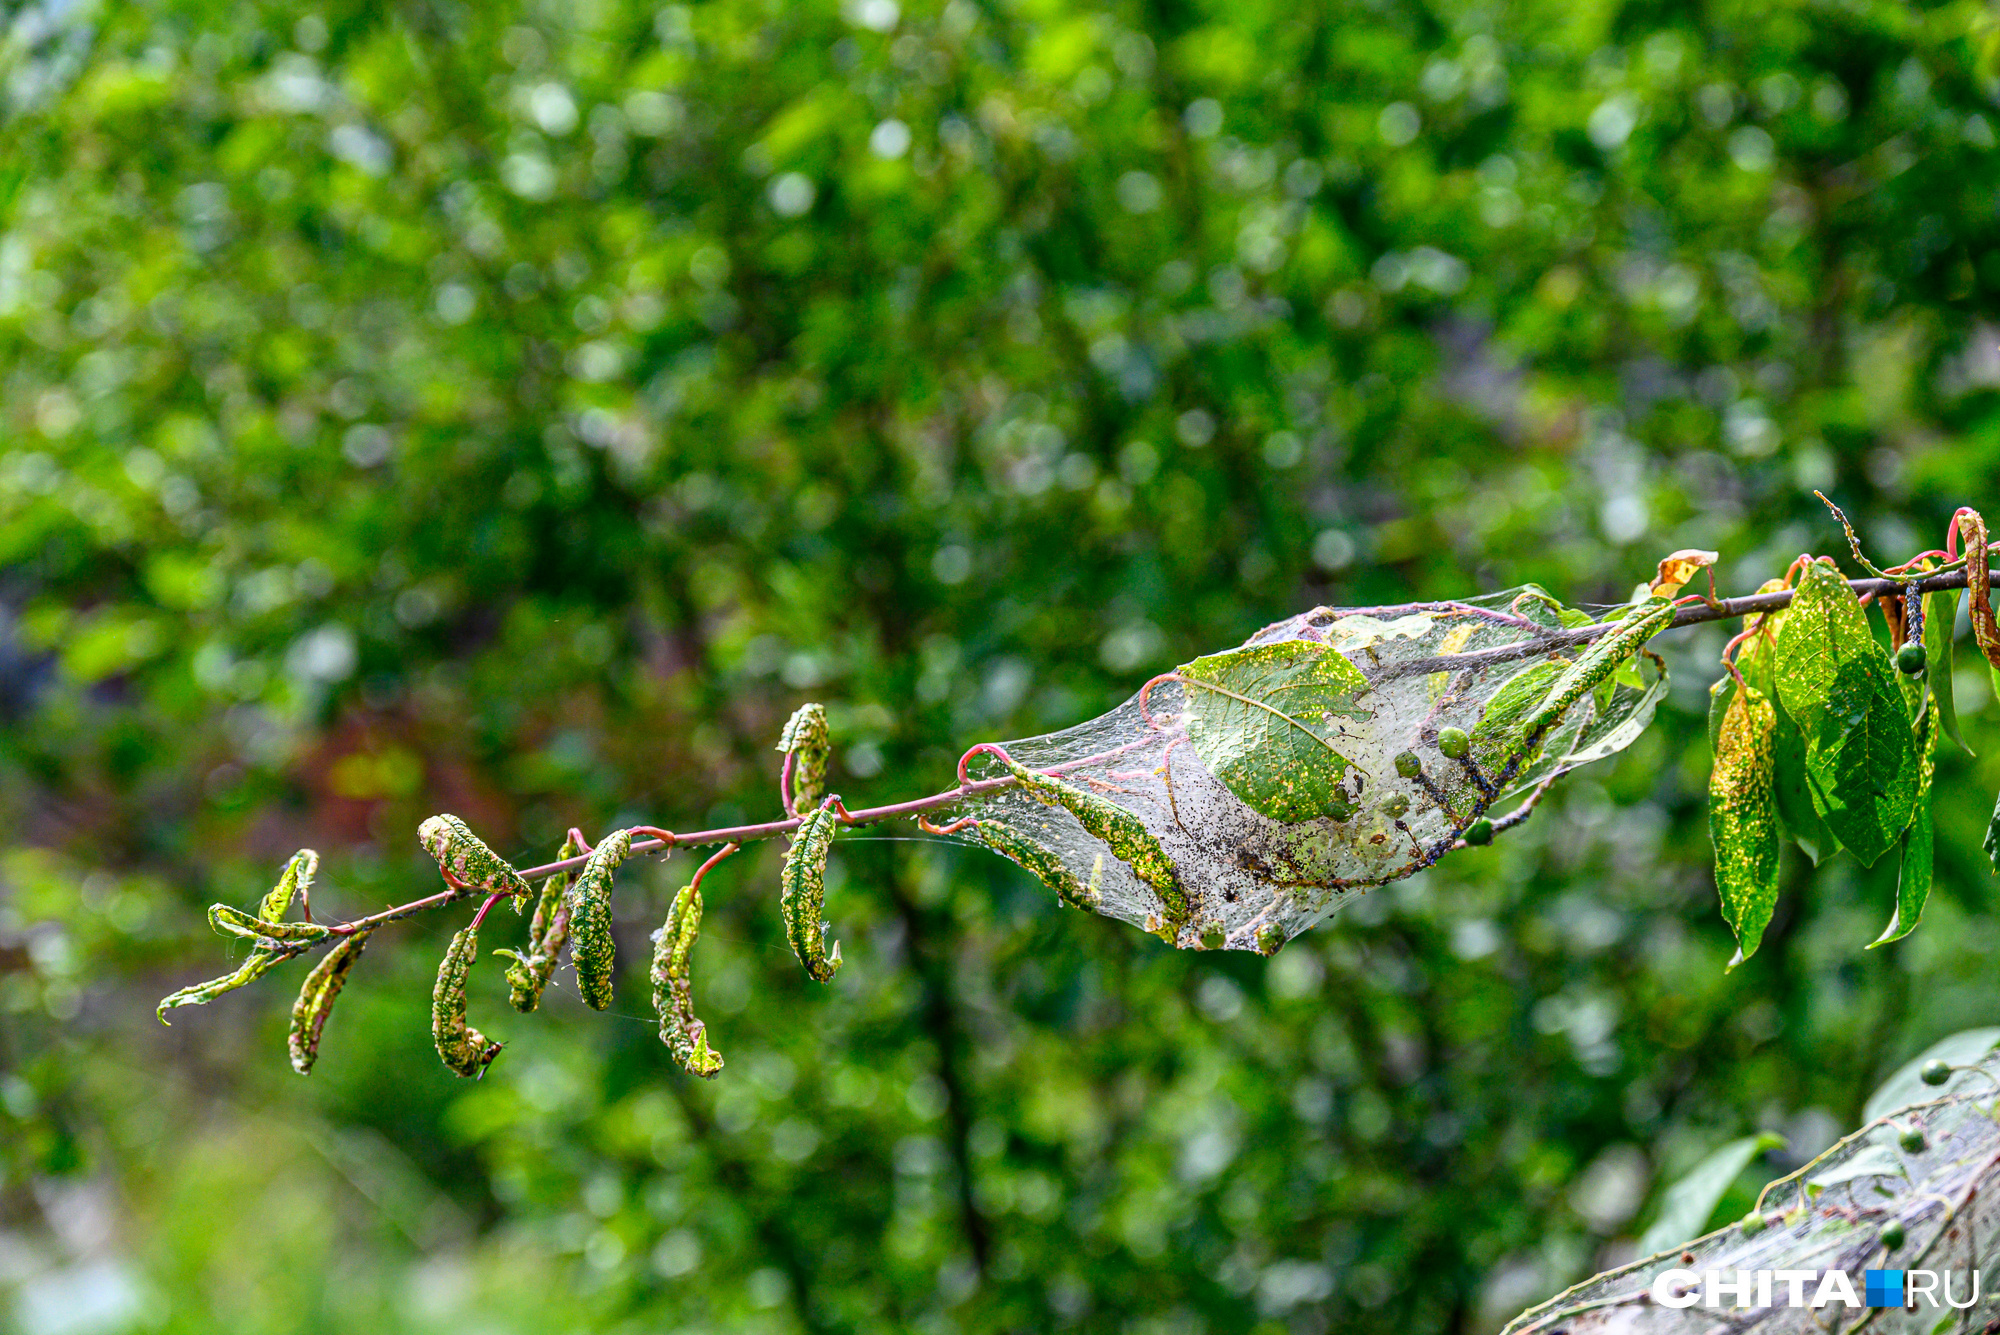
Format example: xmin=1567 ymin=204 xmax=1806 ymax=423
xmin=1178 ymin=640 xmax=1370 ymax=823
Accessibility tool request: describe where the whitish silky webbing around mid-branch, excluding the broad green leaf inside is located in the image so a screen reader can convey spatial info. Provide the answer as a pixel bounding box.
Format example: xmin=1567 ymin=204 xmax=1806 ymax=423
xmin=958 ymin=586 xmax=1666 ymax=949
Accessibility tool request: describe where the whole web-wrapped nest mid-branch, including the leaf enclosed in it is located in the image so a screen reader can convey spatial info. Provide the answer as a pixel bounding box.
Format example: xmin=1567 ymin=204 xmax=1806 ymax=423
xmin=956 ymin=586 xmax=1666 ymax=953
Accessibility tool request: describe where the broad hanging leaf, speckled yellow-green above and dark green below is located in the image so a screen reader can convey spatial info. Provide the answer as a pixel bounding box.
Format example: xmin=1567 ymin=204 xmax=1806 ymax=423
xmin=1776 ymin=562 xmax=1918 ymax=867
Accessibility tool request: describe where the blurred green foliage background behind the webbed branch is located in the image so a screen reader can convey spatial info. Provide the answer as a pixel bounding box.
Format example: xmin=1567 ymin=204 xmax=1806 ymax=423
xmin=0 ymin=0 xmax=2000 ymax=1335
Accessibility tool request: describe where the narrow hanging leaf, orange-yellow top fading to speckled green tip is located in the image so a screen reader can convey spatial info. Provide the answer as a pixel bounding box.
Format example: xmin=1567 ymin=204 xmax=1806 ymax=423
xmin=1708 ymin=685 xmax=1778 ymax=967
